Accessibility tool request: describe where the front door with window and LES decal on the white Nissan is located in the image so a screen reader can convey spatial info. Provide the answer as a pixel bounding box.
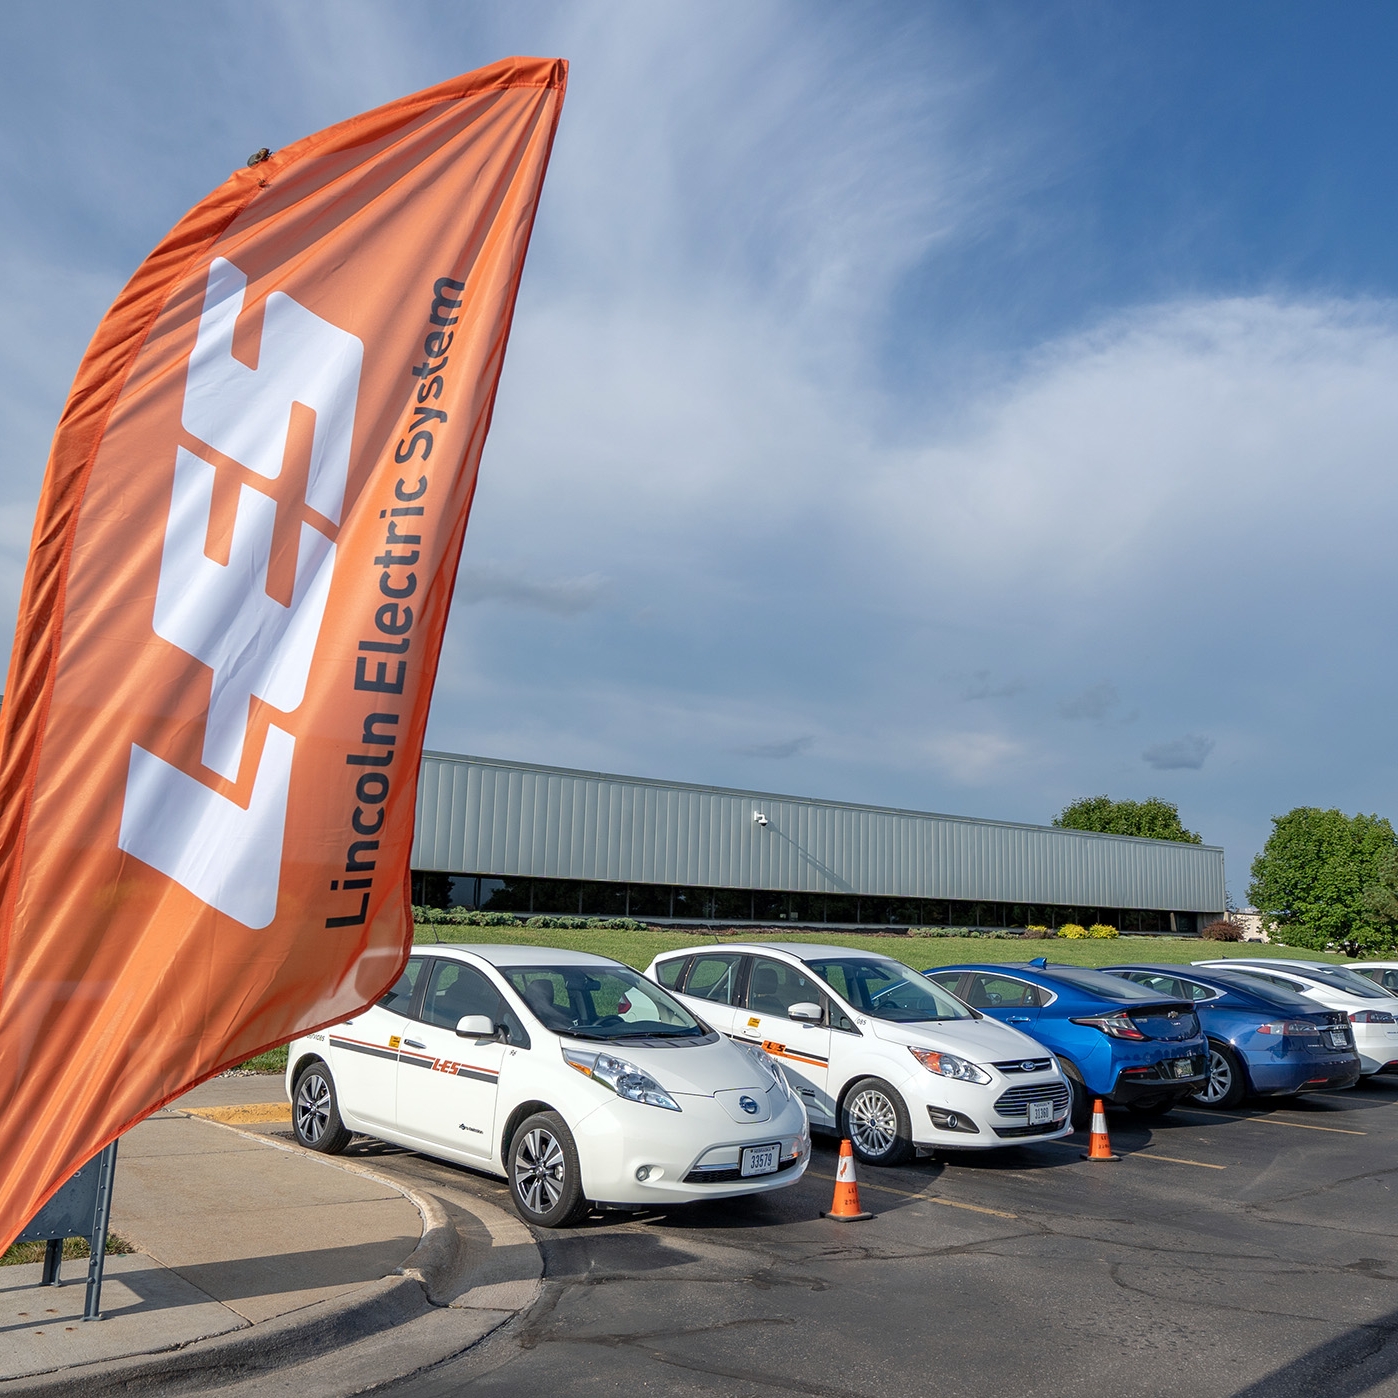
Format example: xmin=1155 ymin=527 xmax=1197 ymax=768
xmin=397 ymin=960 xmax=524 ymax=1159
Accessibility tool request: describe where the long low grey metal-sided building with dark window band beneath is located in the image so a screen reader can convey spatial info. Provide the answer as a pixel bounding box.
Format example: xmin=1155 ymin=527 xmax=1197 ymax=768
xmin=412 ymin=752 xmax=1226 ymax=932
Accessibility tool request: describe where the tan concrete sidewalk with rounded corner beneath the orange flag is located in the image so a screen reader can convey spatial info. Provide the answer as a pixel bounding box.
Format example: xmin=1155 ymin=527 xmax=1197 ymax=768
xmin=0 ymin=1075 xmax=530 ymax=1394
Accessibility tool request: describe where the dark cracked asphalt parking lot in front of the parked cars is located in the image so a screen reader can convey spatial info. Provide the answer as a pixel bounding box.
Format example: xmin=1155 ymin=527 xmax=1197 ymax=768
xmin=343 ymin=1079 xmax=1398 ymax=1398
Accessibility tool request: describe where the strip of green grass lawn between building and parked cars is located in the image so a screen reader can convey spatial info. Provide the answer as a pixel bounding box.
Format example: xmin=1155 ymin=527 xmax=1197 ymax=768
xmin=417 ymin=925 xmax=1346 ymax=970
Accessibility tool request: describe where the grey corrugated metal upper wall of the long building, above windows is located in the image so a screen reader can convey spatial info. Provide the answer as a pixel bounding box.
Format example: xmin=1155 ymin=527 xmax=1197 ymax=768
xmin=412 ymin=752 xmax=1225 ymax=913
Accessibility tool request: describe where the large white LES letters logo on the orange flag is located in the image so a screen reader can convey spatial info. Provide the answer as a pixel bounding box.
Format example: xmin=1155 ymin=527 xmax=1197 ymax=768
xmin=117 ymin=257 xmax=363 ymax=927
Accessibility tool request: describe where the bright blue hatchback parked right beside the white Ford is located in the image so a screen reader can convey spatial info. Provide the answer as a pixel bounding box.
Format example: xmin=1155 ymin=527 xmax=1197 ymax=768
xmin=923 ymin=958 xmax=1208 ymax=1127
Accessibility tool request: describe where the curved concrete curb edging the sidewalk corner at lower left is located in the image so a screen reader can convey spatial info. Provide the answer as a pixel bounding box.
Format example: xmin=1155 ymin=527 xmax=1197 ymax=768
xmin=0 ymin=1117 xmax=542 ymax=1398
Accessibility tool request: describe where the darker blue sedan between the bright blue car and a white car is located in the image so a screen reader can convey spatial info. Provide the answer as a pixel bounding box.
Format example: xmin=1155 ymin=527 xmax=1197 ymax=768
xmin=1104 ymin=966 xmax=1359 ymax=1109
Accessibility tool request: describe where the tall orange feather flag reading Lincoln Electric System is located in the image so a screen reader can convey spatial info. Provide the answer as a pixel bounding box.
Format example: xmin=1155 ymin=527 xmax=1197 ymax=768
xmin=0 ymin=59 xmax=568 ymax=1247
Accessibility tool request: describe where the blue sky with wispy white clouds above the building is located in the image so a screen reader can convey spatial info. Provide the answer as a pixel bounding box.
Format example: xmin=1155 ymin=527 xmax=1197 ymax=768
xmin=0 ymin=0 xmax=1398 ymax=902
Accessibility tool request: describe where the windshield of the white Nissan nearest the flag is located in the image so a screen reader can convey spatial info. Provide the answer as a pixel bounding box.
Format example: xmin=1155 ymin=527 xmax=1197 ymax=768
xmin=499 ymin=963 xmax=709 ymax=1040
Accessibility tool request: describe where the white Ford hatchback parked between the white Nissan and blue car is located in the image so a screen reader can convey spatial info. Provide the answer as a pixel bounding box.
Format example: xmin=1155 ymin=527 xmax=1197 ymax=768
xmin=647 ymin=942 xmax=1072 ymax=1165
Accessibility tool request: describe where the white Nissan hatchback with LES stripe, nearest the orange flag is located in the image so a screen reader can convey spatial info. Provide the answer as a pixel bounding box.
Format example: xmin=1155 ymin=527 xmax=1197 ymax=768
xmin=287 ymin=946 xmax=811 ymax=1227
